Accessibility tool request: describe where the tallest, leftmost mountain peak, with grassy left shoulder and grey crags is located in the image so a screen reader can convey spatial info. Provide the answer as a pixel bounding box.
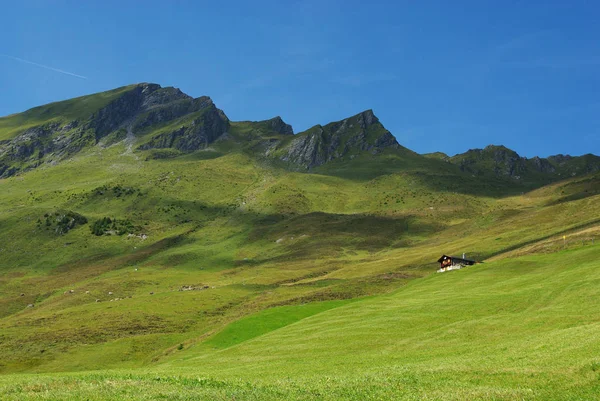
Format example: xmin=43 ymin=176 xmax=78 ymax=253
xmin=0 ymin=84 xmax=229 ymax=177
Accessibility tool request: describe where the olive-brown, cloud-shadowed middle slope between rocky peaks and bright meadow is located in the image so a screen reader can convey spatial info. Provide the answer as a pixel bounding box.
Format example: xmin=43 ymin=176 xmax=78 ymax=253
xmin=0 ymin=138 xmax=600 ymax=372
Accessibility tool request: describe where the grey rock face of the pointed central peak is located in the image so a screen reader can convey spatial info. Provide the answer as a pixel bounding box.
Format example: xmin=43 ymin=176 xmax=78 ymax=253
xmin=281 ymin=110 xmax=399 ymax=169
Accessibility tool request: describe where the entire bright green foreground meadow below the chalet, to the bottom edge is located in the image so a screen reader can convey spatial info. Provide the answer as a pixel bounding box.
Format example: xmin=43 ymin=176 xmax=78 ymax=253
xmin=0 ymin=245 xmax=600 ymax=400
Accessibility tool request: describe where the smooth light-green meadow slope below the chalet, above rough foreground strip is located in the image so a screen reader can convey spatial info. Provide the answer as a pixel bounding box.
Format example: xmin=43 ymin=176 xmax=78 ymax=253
xmin=165 ymin=246 xmax=600 ymax=399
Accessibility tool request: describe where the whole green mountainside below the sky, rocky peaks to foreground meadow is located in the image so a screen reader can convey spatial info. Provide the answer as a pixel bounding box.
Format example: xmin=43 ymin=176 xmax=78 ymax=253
xmin=0 ymin=84 xmax=600 ymax=399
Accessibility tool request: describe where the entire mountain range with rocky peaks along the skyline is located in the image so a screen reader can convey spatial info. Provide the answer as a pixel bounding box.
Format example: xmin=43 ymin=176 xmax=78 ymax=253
xmin=0 ymin=83 xmax=600 ymax=188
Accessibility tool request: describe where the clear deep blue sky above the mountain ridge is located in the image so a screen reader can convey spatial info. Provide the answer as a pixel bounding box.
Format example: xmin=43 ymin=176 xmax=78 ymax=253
xmin=0 ymin=0 xmax=600 ymax=157
